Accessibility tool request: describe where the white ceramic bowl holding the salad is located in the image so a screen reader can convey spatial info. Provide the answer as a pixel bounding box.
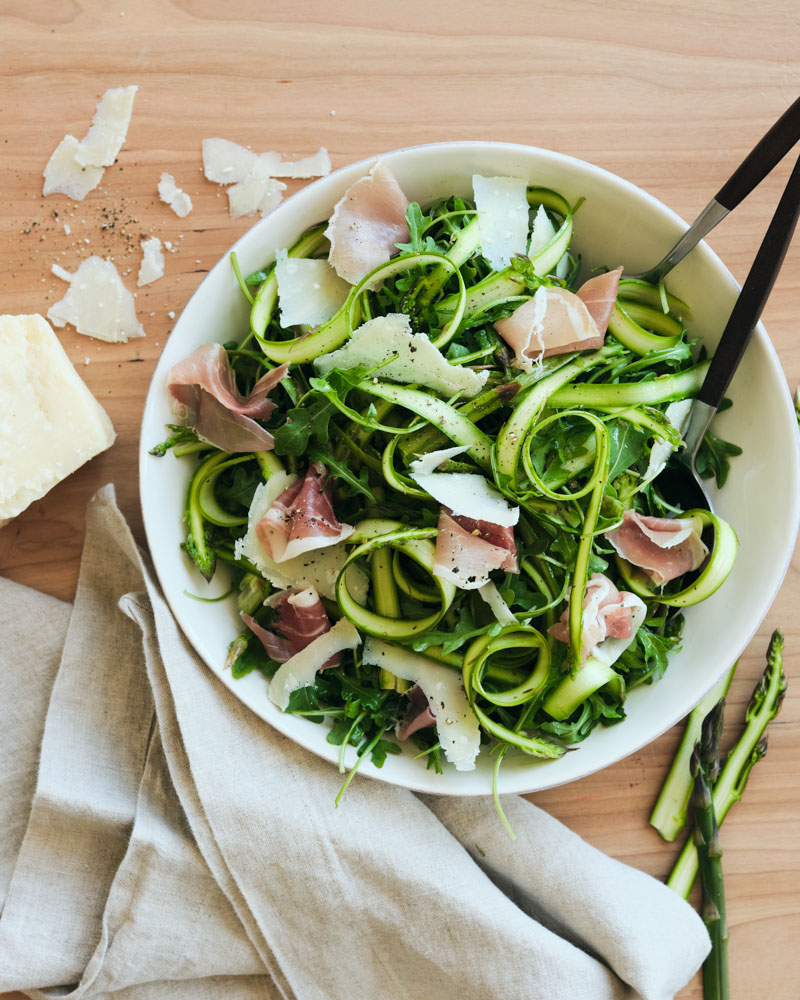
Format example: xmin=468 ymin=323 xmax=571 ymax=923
xmin=140 ymin=142 xmax=800 ymax=795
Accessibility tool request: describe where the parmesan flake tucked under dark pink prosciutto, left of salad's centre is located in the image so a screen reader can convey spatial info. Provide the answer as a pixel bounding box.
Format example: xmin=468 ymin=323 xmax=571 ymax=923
xmin=235 ymin=472 xmax=369 ymax=604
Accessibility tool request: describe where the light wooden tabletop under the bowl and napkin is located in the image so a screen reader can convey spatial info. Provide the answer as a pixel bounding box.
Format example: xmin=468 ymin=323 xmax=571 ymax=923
xmin=0 ymin=0 xmax=800 ymax=1000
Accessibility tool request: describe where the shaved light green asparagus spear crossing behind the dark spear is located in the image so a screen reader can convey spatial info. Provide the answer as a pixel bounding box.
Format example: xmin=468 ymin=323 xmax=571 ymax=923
xmin=667 ymin=629 xmax=786 ymax=899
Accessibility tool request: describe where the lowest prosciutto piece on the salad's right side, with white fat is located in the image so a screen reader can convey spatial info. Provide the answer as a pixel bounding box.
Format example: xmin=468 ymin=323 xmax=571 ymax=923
xmin=547 ymin=573 xmax=646 ymax=664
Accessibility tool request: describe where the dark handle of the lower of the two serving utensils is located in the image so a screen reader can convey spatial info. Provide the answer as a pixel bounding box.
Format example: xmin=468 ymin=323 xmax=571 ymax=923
xmin=697 ymin=150 xmax=800 ymax=407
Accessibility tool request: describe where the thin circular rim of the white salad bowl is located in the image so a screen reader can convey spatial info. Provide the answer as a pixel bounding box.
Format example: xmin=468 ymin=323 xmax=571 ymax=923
xmin=139 ymin=139 xmax=800 ymax=796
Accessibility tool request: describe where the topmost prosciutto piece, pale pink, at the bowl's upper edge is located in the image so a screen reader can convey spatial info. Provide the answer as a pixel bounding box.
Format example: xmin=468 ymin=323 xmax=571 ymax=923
xmin=325 ymin=160 xmax=411 ymax=285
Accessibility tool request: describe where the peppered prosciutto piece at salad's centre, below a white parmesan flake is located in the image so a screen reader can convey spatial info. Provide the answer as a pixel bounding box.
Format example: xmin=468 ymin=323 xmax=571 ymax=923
xmin=433 ymin=507 xmax=518 ymax=590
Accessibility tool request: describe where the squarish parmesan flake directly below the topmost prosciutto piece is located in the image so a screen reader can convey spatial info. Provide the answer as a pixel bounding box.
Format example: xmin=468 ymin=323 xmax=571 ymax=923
xmin=275 ymin=250 xmax=350 ymax=327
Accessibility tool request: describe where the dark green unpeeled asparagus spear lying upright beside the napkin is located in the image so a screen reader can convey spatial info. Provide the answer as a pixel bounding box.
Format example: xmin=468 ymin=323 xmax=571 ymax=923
xmin=692 ymin=698 xmax=729 ymax=1000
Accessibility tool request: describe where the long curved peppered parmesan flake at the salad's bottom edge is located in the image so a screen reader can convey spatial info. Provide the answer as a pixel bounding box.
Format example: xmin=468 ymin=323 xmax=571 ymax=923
xmin=362 ymin=637 xmax=481 ymax=771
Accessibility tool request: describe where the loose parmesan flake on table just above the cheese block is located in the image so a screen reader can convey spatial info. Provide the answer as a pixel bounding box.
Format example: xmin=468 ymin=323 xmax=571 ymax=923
xmin=47 ymin=257 xmax=144 ymax=344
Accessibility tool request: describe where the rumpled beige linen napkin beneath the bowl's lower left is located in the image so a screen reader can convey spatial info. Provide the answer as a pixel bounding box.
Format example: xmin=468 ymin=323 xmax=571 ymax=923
xmin=0 ymin=487 xmax=708 ymax=1000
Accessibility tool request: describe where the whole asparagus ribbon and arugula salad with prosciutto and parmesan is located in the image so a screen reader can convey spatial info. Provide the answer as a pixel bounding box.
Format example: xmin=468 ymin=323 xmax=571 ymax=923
xmin=153 ymin=162 xmax=739 ymax=808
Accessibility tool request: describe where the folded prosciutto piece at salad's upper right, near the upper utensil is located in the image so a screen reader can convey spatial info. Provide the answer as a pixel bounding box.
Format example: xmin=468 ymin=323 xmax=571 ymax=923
xmin=494 ymin=267 xmax=622 ymax=371
